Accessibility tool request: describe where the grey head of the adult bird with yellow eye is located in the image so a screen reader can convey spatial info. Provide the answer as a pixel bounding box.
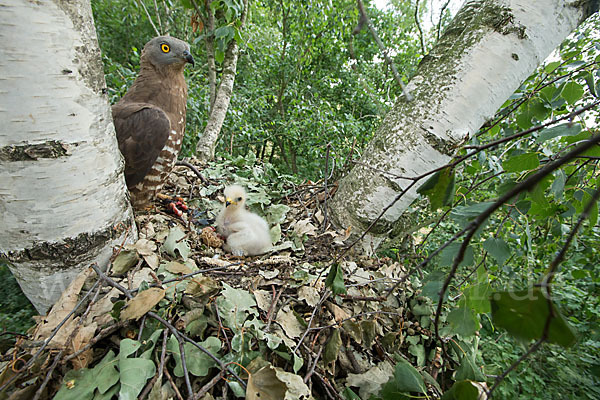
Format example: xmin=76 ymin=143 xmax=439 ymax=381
xmin=142 ymin=36 xmax=194 ymax=68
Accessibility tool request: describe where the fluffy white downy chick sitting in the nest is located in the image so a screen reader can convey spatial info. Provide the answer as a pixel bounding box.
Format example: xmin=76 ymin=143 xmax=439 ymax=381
xmin=217 ymin=185 xmax=271 ymax=256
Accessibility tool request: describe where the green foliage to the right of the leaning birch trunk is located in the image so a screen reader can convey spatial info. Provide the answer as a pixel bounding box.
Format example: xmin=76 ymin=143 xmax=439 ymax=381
xmin=408 ymin=16 xmax=600 ymax=398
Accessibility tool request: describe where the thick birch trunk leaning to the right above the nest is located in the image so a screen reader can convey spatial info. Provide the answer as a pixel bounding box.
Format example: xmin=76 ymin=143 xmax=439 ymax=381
xmin=330 ymin=0 xmax=598 ymax=250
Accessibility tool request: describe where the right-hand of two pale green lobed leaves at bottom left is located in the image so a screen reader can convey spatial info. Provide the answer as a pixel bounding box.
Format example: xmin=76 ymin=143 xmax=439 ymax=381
xmin=119 ymin=339 xmax=156 ymax=400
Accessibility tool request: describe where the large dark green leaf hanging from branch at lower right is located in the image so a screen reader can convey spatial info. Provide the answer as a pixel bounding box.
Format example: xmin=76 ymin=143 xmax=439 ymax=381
xmin=491 ymin=287 xmax=576 ymax=347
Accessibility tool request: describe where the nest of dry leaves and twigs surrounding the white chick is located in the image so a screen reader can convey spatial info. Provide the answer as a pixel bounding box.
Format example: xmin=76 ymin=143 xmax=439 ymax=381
xmin=0 ymin=160 xmax=450 ymax=400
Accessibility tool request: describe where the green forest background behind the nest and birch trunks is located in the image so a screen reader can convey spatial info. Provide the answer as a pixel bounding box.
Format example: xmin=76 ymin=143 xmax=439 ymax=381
xmin=1 ymin=0 xmax=600 ymax=399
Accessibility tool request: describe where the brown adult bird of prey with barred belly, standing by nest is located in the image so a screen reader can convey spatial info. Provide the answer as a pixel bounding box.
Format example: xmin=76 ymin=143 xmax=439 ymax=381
xmin=112 ymin=36 xmax=194 ymax=209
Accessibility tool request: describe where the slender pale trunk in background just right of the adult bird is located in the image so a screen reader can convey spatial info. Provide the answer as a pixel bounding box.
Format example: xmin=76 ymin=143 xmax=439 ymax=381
xmin=196 ymin=0 xmax=248 ymax=161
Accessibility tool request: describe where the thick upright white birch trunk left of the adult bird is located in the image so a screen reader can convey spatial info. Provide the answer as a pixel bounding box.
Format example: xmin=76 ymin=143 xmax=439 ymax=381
xmin=0 ymin=0 xmax=137 ymax=313
